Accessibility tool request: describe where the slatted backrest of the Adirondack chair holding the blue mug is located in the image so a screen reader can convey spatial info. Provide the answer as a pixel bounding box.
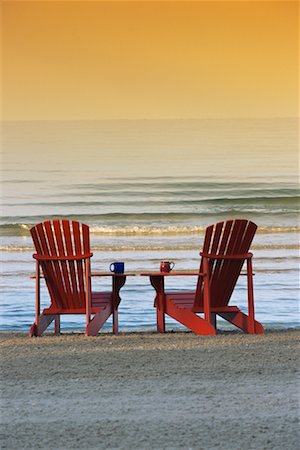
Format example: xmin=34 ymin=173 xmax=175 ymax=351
xmin=30 ymin=220 xmax=90 ymax=310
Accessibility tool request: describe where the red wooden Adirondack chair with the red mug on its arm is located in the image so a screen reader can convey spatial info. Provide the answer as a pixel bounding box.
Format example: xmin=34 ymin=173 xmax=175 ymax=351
xmin=145 ymin=220 xmax=264 ymax=335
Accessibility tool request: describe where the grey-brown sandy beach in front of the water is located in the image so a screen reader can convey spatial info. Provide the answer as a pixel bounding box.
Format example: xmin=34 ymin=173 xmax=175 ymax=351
xmin=0 ymin=330 xmax=300 ymax=450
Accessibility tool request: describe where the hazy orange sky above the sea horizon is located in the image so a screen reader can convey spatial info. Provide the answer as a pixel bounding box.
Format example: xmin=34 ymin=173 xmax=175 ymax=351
xmin=1 ymin=0 xmax=298 ymax=120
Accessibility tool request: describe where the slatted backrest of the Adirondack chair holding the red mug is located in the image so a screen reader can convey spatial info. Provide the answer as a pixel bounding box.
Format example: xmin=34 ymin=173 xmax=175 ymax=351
xmin=194 ymin=219 xmax=257 ymax=306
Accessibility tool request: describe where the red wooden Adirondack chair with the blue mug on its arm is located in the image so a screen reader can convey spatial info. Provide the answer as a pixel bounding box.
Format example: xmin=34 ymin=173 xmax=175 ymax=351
xmin=30 ymin=220 xmax=126 ymax=336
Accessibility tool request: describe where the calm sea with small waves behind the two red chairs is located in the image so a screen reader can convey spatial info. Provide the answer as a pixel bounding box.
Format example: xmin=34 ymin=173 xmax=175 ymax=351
xmin=0 ymin=119 xmax=300 ymax=331
